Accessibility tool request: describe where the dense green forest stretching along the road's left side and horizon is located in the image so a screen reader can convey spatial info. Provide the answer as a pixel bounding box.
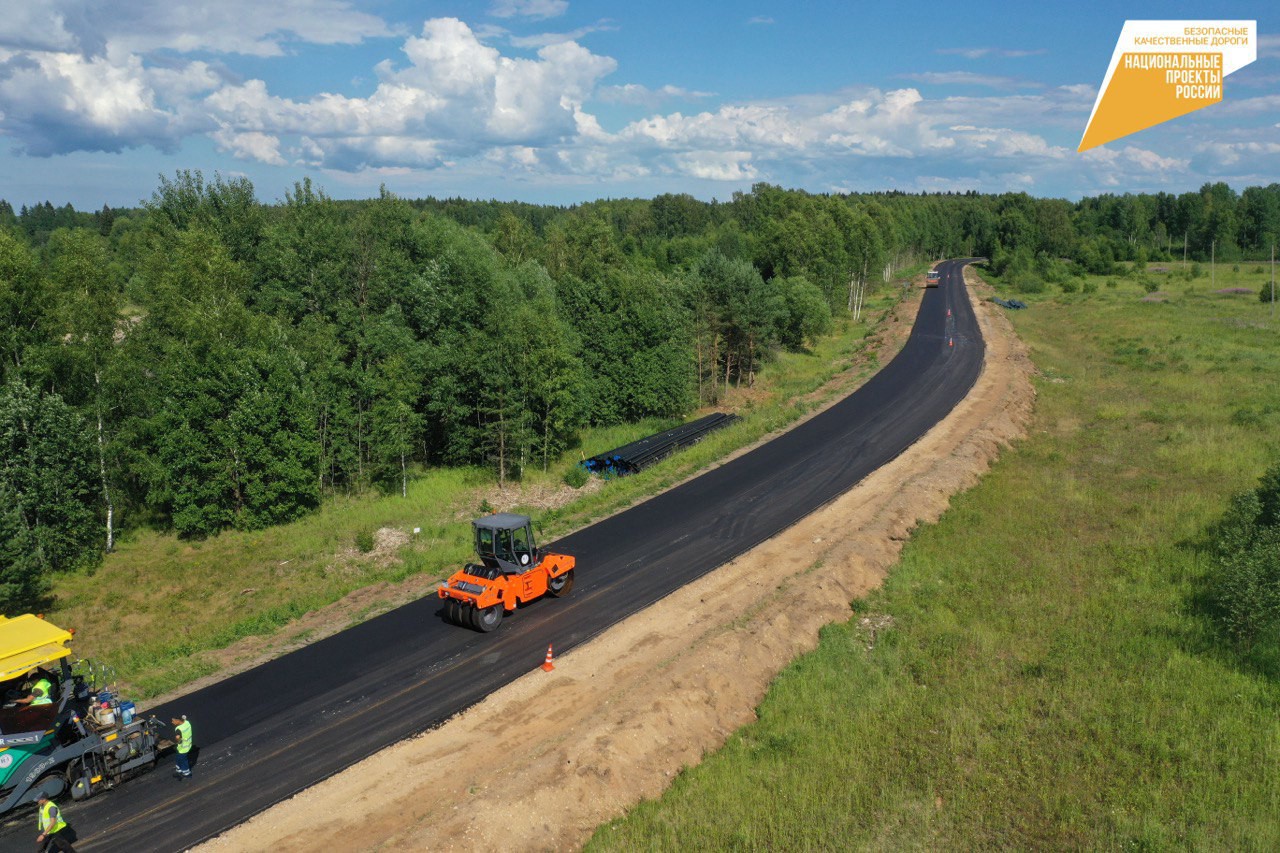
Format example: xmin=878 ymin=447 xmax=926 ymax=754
xmin=0 ymin=172 xmax=1280 ymax=613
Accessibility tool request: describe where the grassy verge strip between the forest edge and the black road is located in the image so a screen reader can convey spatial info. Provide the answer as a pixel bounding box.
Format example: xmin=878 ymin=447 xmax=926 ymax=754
xmin=49 ymin=277 xmax=921 ymax=698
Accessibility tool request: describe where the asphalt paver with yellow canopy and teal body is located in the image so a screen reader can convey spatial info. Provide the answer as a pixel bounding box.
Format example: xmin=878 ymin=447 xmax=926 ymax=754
xmin=0 ymin=613 xmax=172 ymax=813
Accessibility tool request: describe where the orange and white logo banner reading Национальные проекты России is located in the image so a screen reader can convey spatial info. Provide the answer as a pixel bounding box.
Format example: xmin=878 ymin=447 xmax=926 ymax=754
xmin=1076 ymin=20 xmax=1258 ymax=151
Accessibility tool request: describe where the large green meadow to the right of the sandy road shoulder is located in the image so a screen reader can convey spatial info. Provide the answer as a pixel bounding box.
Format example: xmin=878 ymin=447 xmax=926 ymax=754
xmin=589 ymin=264 xmax=1280 ymax=850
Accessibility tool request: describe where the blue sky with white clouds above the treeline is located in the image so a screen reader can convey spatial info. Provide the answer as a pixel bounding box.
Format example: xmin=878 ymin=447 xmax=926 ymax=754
xmin=0 ymin=0 xmax=1280 ymax=210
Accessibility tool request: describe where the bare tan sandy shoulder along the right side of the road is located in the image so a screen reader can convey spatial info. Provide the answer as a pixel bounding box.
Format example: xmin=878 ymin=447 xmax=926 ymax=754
xmin=201 ymin=270 xmax=1034 ymax=850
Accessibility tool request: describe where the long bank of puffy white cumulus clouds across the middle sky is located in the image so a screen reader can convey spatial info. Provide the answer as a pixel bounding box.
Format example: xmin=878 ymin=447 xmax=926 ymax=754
xmin=194 ymin=62 xmax=1157 ymax=184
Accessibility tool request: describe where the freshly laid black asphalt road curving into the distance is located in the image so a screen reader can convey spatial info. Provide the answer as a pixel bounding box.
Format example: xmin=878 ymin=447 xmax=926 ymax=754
xmin=0 ymin=261 xmax=983 ymax=852
